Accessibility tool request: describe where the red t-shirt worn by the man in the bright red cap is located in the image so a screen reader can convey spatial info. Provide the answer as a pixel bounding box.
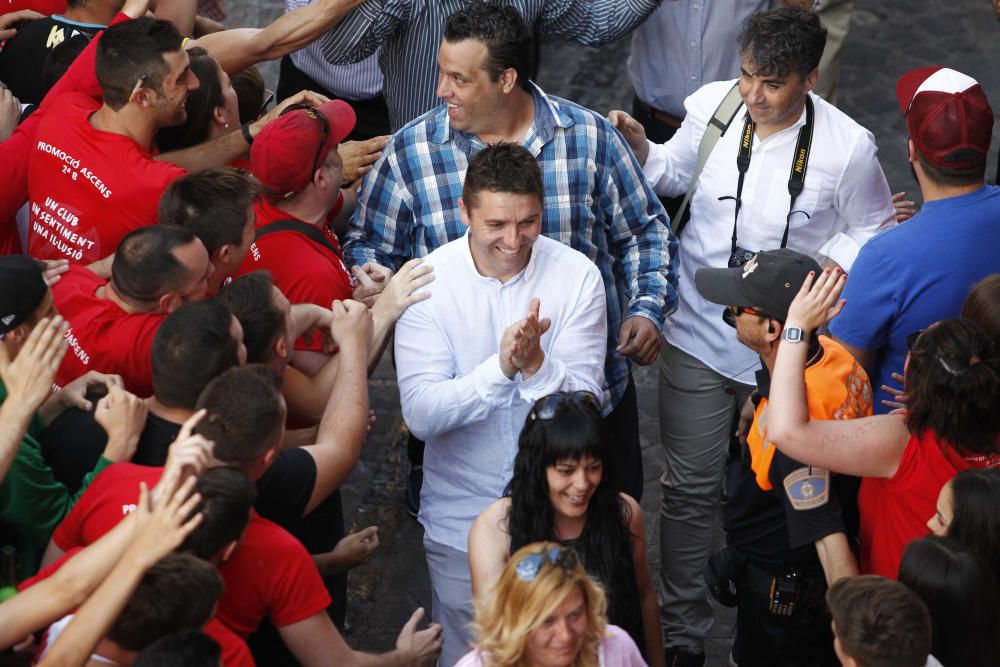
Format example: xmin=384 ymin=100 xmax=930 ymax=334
xmin=233 ymin=198 xmax=354 ymax=350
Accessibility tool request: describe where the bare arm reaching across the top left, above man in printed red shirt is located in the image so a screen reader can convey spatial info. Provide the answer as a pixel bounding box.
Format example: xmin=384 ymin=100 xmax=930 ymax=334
xmin=197 ymin=0 xmax=363 ymax=74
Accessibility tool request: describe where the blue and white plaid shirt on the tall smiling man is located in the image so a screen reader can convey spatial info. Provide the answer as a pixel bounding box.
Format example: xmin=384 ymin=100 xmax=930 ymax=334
xmin=344 ymin=86 xmax=677 ymax=412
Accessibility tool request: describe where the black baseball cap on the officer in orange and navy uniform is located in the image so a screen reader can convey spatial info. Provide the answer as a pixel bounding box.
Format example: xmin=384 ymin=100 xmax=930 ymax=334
xmin=694 ymin=248 xmax=821 ymax=322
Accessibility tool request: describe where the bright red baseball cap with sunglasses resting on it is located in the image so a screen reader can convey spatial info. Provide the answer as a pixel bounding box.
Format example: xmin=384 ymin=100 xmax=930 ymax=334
xmin=250 ymin=100 xmax=356 ymax=197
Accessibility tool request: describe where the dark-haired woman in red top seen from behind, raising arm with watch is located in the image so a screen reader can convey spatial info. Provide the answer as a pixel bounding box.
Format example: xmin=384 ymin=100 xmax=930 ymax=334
xmin=768 ymin=270 xmax=1000 ymax=578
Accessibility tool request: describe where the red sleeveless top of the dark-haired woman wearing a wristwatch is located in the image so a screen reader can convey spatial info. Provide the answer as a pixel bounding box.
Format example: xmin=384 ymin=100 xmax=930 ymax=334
xmin=858 ymin=429 xmax=1000 ymax=579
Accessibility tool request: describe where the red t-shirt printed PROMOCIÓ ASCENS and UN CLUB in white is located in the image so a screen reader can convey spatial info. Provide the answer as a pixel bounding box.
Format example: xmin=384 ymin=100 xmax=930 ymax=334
xmin=28 ymin=92 xmax=187 ymax=264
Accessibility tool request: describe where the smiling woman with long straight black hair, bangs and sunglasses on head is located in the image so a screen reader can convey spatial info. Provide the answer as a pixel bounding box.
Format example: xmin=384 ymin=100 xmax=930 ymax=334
xmin=469 ymin=392 xmax=663 ymax=667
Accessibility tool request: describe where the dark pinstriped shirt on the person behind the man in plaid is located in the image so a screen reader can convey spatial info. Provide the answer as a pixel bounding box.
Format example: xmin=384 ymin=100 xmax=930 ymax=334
xmin=319 ymin=0 xmax=660 ymax=132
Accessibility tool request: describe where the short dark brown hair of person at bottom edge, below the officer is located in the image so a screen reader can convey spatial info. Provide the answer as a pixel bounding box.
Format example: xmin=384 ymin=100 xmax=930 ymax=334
xmin=826 ymin=574 xmax=931 ymax=667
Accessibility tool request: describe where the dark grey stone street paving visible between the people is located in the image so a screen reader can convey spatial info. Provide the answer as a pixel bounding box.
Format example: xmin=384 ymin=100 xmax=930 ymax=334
xmin=227 ymin=0 xmax=1000 ymax=666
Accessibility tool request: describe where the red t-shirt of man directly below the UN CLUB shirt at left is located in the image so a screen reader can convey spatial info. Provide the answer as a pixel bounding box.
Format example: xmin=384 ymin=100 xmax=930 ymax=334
xmin=52 ymin=266 xmax=166 ymax=397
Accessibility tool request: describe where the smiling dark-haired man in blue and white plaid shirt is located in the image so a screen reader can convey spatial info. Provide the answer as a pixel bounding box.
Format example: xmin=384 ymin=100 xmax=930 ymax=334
xmin=344 ymin=3 xmax=677 ymax=506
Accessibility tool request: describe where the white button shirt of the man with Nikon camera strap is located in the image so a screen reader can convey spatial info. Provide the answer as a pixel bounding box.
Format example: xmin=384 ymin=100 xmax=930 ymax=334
xmin=643 ymin=81 xmax=896 ymax=384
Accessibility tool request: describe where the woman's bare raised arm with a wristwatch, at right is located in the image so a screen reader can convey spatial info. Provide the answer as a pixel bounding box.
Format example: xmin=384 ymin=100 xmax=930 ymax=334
xmin=767 ymin=270 xmax=909 ymax=477
